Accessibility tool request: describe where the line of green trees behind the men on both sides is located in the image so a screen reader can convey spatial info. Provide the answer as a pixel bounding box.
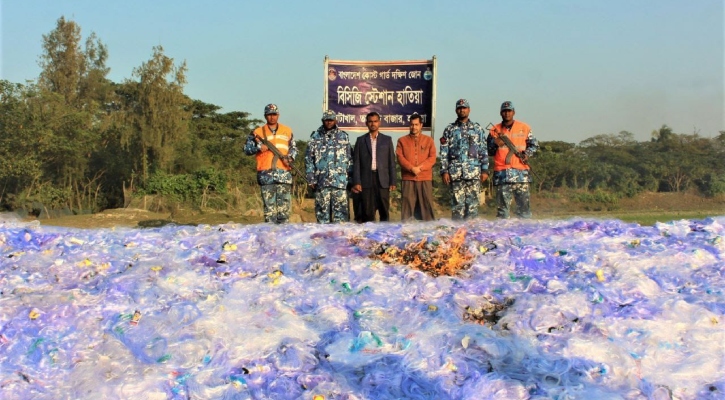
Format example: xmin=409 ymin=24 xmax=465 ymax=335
xmin=0 ymin=17 xmax=725 ymax=213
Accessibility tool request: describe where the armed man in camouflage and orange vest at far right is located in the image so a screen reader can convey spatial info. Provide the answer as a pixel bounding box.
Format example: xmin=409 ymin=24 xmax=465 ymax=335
xmin=486 ymin=101 xmax=539 ymax=218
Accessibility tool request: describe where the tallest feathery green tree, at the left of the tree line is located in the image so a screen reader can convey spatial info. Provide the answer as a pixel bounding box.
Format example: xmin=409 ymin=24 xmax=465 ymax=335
xmin=26 ymin=17 xmax=112 ymax=209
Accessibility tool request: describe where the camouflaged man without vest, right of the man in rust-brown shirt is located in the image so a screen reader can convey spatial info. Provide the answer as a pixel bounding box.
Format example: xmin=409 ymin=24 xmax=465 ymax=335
xmin=441 ymin=99 xmax=488 ymax=220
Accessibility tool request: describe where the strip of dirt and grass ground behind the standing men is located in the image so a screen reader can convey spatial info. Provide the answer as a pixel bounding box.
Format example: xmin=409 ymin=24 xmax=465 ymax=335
xmin=19 ymin=193 xmax=725 ymax=229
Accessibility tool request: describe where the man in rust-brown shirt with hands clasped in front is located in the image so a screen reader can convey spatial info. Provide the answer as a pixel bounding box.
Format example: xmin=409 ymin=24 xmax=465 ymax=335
xmin=395 ymin=114 xmax=436 ymax=221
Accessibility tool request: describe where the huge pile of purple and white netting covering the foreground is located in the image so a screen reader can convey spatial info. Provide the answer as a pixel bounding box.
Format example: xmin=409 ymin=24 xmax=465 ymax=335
xmin=0 ymin=217 xmax=725 ymax=400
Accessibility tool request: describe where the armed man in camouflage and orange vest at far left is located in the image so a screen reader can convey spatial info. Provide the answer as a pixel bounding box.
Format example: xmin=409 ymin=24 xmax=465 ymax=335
xmin=244 ymin=104 xmax=297 ymax=224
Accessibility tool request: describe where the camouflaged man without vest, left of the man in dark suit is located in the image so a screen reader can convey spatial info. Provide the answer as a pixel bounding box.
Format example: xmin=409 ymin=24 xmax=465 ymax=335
xmin=305 ymin=110 xmax=352 ymax=224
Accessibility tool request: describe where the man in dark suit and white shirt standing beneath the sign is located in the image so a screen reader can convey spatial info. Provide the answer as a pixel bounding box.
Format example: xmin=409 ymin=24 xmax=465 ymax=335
xmin=352 ymin=112 xmax=397 ymax=222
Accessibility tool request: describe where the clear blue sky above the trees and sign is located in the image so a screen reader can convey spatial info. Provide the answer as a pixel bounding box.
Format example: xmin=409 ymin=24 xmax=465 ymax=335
xmin=0 ymin=0 xmax=725 ymax=143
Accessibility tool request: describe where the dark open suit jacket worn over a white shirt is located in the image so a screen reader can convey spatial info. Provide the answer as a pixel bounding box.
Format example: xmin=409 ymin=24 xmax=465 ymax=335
xmin=352 ymin=133 xmax=397 ymax=189
